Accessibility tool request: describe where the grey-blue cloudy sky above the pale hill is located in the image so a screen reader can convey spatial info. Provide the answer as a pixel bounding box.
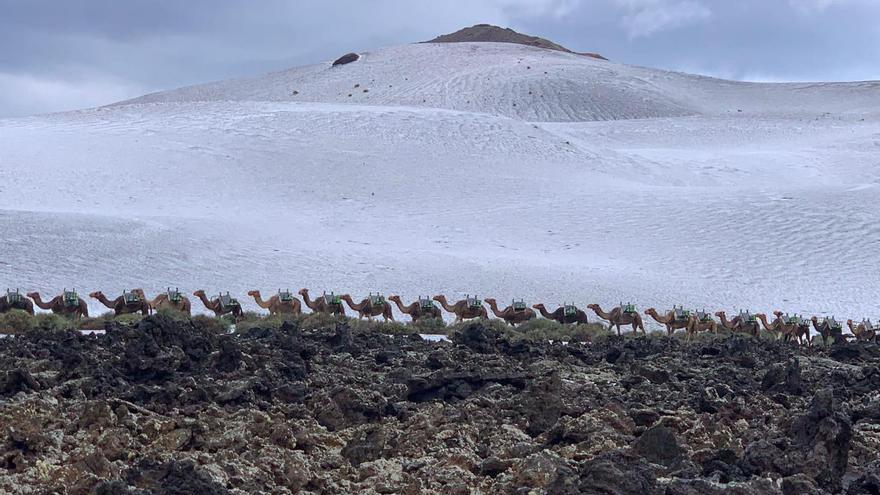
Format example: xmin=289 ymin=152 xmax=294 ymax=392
xmin=0 ymin=0 xmax=880 ymax=118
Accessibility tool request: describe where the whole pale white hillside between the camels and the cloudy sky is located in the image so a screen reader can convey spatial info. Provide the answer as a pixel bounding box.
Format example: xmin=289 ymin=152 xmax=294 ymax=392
xmin=0 ymin=44 xmax=880 ymax=330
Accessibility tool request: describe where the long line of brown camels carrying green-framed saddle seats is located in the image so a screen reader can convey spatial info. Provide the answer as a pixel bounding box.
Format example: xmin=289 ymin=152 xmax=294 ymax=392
xmin=0 ymin=287 xmax=880 ymax=345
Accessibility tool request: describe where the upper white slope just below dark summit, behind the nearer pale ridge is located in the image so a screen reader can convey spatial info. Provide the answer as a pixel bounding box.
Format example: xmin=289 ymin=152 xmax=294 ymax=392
xmin=125 ymin=36 xmax=880 ymax=122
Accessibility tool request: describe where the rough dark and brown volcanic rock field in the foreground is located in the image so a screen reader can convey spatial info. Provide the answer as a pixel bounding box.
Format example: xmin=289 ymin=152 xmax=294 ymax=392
xmin=0 ymin=315 xmax=880 ymax=494
